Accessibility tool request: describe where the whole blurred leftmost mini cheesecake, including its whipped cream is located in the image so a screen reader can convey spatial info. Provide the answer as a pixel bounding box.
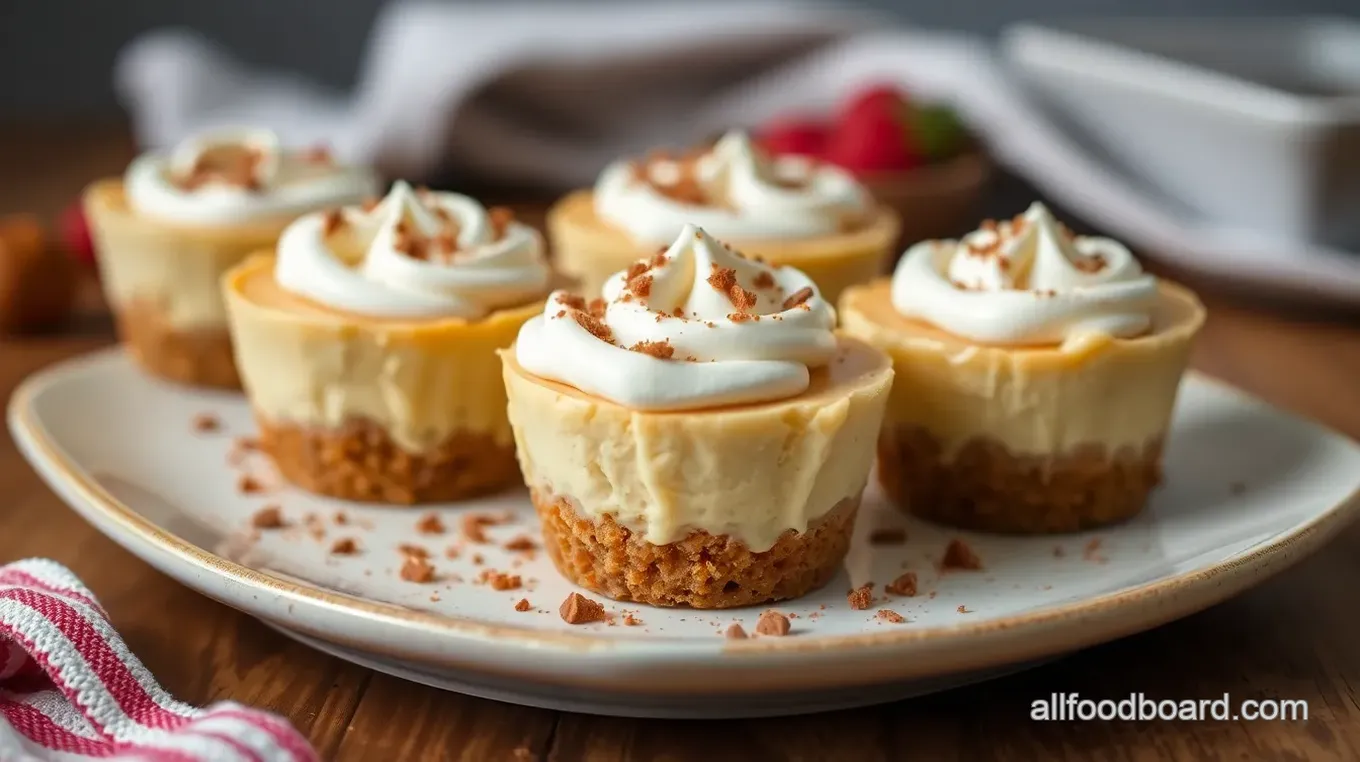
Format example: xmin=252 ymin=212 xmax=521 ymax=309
xmin=84 ymin=129 xmax=379 ymax=388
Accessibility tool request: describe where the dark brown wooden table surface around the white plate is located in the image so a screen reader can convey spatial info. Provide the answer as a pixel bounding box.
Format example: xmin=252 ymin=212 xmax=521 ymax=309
xmin=0 ymin=121 xmax=1360 ymax=762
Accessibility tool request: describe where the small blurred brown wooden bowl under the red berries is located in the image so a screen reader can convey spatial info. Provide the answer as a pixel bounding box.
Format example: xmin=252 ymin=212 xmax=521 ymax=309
xmin=860 ymin=151 xmax=991 ymax=263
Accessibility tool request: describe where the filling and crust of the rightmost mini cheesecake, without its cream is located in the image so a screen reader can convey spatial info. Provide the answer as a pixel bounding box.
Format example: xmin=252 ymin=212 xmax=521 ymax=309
xmin=840 ymin=279 xmax=1205 ymax=533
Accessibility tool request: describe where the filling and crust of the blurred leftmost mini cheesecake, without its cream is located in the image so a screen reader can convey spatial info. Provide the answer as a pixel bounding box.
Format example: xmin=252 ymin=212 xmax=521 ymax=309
xmin=84 ymin=180 xmax=296 ymax=389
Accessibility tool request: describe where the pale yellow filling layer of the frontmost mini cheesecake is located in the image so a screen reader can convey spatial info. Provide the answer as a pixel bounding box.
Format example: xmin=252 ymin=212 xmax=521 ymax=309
xmin=503 ymin=337 xmax=892 ymax=552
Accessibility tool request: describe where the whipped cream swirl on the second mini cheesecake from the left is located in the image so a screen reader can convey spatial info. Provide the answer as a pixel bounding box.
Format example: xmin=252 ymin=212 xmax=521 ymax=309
xmin=275 ymin=181 xmax=551 ymax=320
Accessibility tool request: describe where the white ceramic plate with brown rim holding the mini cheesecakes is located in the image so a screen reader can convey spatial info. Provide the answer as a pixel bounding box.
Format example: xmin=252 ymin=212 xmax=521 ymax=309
xmin=10 ymin=351 xmax=1360 ymax=716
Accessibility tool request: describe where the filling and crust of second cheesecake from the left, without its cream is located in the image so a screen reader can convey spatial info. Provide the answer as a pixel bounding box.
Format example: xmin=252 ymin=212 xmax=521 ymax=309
xmin=222 ymin=253 xmax=543 ymax=505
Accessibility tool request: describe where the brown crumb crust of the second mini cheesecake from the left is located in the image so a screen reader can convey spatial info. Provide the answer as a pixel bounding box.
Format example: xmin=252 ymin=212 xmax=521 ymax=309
xmin=257 ymin=416 xmax=521 ymax=505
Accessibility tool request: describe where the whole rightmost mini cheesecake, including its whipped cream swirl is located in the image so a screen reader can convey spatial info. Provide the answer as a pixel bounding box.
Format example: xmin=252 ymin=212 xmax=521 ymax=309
xmin=840 ymin=204 xmax=1205 ymax=532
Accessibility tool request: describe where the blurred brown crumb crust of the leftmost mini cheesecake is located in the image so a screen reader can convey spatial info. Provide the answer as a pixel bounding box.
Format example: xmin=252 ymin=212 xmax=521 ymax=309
xmin=116 ymin=301 xmax=241 ymax=391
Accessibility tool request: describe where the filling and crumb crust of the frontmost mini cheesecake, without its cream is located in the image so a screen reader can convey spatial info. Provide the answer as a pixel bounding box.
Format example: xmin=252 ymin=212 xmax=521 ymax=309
xmin=500 ymin=337 xmax=892 ymax=608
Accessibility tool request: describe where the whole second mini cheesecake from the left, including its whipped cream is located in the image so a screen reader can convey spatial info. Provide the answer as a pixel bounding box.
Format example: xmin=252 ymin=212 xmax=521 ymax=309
xmin=222 ymin=182 xmax=549 ymax=503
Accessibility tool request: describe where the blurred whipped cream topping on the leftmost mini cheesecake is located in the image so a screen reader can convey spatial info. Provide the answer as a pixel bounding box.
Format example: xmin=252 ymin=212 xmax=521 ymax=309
xmin=124 ymin=129 xmax=379 ymax=225
